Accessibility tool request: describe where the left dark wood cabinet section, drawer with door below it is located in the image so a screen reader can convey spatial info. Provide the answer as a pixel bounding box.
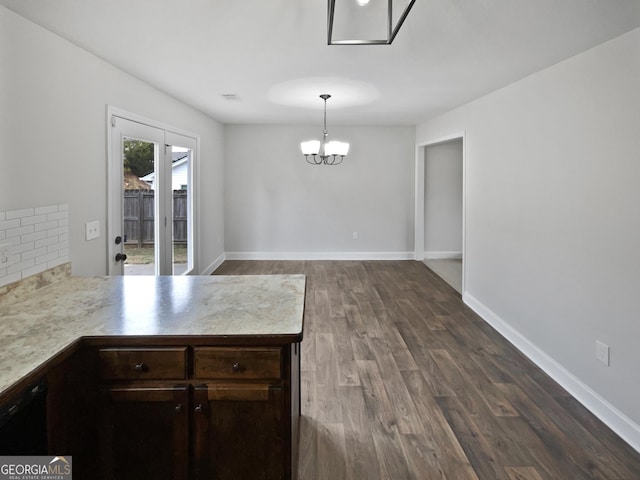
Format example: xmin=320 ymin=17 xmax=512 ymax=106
xmin=98 ymin=347 xmax=191 ymax=480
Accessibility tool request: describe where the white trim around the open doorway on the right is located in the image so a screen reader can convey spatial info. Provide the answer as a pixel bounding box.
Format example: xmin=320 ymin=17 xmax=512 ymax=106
xmin=414 ymin=130 xmax=467 ymax=296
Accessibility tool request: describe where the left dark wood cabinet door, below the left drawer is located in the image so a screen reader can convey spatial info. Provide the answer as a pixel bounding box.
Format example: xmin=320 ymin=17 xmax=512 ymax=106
xmin=100 ymin=385 xmax=189 ymax=480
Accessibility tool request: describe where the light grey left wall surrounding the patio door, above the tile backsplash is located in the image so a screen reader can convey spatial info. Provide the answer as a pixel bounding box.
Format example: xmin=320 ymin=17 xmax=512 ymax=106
xmin=0 ymin=7 xmax=224 ymax=275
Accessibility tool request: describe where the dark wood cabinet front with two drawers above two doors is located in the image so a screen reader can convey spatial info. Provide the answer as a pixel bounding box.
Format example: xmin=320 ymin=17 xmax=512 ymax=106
xmin=97 ymin=344 xmax=300 ymax=480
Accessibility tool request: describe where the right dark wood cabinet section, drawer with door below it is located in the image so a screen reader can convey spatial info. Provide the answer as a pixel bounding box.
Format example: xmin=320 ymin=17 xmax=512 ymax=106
xmin=193 ymin=347 xmax=289 ymax=480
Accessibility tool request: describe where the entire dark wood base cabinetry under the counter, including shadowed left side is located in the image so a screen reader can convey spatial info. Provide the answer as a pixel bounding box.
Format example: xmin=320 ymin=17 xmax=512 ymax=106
xmin=7 ymin=337 xmax=300 ymax=480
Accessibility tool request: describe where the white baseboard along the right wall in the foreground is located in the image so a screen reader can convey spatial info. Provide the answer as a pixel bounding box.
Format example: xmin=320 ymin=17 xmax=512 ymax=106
xmin=462 ymin=293 xmax=640 ymax=452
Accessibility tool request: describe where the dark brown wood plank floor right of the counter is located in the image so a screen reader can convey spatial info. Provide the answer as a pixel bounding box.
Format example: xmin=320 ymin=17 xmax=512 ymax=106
xmin=215 ymin=261 xmax=640 ymax=480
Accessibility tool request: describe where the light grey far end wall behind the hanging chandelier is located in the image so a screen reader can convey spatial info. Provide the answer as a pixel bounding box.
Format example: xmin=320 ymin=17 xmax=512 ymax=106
xmin=225 ymin=124 xmax=415 ymax=258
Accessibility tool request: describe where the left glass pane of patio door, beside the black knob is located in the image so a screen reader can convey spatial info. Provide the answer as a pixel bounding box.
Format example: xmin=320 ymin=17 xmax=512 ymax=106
xmin=122 ymin=138 xmax=157 ymax=275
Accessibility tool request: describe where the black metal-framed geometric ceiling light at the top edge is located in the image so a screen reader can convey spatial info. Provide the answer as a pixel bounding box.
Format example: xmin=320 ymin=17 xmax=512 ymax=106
xmin=327 ymin=0 xmax=416 ymax=45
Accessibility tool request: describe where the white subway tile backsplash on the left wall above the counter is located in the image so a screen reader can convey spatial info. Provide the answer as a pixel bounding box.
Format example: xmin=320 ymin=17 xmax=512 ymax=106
xmin=0 ymin=204 xmax=69 ymax=287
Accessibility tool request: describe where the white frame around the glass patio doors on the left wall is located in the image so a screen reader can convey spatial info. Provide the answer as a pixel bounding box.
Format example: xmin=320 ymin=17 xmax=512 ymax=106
xmin=105 ymin=105 xmax=200 ymax=275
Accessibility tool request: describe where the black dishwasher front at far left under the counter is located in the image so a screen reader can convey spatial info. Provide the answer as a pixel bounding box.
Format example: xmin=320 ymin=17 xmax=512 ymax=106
xmin=0 ymin=380 xmax=48 ymax=455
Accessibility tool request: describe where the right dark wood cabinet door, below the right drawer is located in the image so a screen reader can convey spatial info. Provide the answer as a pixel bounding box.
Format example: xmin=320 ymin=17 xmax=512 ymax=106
xmin=194 ymin=383 xmax=284 ymax=480
